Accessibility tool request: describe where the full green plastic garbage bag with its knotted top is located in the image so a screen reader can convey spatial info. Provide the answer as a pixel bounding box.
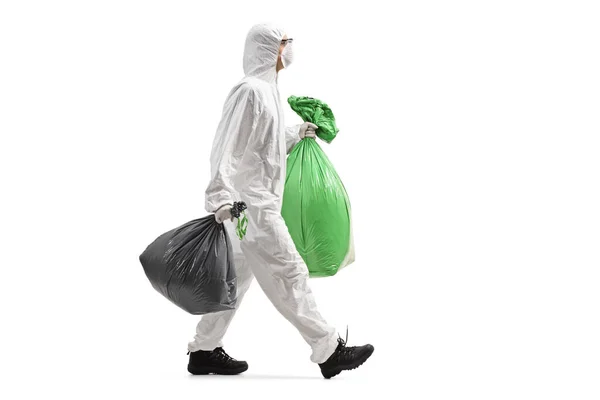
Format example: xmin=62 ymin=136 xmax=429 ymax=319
xmin=281 ymin=96 xmax=354 ymax=277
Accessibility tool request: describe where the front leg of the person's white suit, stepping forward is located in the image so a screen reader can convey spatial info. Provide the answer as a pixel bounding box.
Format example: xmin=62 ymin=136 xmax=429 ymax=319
xmin=241 ymin=211 xmax=338 ymax=363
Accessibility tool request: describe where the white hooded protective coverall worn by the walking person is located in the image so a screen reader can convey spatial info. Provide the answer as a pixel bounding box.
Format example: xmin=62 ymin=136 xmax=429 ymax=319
xmin=188 ymin=24 xmax=338 ymax=363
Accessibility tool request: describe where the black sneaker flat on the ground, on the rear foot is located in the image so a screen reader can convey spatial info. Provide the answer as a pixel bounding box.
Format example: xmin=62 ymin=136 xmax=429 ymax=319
xmin=188 ymin=347 xmax=248 ymax=375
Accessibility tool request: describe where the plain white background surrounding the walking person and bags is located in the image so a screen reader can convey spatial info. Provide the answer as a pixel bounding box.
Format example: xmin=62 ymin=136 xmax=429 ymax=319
xmin=0 ymin=0 xmax=600 ymax=400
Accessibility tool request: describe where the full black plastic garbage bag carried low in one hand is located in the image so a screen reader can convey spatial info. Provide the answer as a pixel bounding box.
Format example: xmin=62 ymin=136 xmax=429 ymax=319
xmin=139 ymin=214 xmax=237 ymax=315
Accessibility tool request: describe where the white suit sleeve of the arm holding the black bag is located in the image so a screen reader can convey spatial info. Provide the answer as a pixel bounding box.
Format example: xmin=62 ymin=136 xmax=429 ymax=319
xmin=205 ymin=85 xmax=259 ymax=213
